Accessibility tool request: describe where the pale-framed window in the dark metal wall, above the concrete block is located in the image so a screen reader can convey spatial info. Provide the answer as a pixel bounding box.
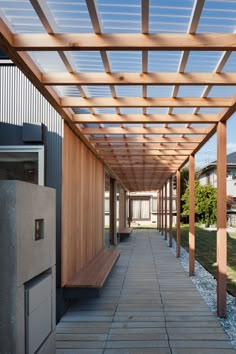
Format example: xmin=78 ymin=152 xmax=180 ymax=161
xmin=0 ymin=145 xmax=44 ymax=186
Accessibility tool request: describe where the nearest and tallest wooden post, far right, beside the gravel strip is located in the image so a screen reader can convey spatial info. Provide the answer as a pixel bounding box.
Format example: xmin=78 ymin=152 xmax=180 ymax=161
xmin=217 ymin=122 xmax=227 ymax=317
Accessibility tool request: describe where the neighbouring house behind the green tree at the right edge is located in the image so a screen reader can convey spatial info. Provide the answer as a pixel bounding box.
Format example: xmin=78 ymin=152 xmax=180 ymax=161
xmin=199 ymin=152 xmax=236 ymax=203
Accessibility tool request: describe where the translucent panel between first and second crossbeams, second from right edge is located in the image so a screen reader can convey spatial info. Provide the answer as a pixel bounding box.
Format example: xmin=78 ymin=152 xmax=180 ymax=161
xmin=185 ymin=51 xmax=222 ymax=72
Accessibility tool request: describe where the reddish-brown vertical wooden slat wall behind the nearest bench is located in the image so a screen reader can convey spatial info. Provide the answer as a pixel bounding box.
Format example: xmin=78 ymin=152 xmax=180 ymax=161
xmin=61 ymin=124 xmax=104 ymax=286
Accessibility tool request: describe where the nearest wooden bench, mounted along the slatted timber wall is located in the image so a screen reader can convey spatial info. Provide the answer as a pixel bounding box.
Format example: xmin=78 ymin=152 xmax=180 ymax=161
xmin=66 ymin=248 xmax=120 ymax=289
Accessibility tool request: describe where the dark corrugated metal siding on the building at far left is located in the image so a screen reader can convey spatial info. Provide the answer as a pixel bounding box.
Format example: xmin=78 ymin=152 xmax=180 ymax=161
xmin=0 ymin=66 xmax=63 ymax=283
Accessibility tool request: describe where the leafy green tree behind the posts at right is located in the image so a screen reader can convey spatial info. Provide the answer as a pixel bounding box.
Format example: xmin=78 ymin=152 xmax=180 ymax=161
xmin=182 ymin=180 xmax=217 ymax=226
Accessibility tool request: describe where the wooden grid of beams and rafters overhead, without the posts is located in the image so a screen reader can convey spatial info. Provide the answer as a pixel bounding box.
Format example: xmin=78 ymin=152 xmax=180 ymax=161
xmin=0 ymin=0 xmax=236 ymax=191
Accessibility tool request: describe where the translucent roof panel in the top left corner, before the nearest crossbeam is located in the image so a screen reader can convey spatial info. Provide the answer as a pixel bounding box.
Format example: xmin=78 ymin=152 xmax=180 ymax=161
xmin=0 ymin=0 xmax=45 ymax=33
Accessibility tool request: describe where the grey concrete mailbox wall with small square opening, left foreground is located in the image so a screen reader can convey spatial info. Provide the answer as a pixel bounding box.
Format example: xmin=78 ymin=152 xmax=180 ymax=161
xmin=0 ymin=181 xmax=56 ymax=354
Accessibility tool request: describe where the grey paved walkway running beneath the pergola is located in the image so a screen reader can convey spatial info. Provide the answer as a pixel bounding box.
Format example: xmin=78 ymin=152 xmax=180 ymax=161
xmin=57 ymin=230 xmax=236 ymax=354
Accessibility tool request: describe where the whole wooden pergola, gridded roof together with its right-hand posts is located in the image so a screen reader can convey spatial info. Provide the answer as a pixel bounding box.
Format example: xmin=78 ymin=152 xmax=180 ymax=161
xmin=0 ymin=0 xmax=236 ymax=317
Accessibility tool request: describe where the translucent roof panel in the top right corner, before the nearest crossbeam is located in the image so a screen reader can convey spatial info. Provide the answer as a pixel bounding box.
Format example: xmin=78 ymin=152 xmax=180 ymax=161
xmin=197 ymin=0 xmax=236 ymax=33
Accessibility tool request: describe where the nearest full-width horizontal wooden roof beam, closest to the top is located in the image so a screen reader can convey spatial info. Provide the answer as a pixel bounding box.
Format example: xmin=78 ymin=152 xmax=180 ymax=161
xmin=10 ymin=33 xmax=236 ymax=51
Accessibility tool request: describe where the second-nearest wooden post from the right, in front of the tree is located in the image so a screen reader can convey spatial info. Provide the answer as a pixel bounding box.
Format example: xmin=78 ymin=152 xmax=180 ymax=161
xmin=189 ymin=155 xmax=195 ymax=276
